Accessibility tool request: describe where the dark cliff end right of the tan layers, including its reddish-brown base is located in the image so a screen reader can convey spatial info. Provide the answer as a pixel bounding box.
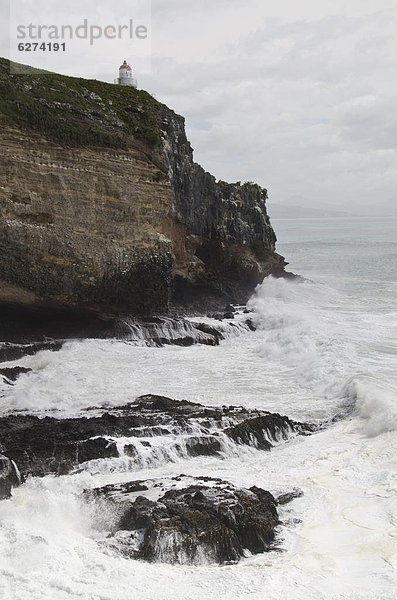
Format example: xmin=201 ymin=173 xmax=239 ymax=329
xmin=161 ymin=110 xmax=285 ymax=305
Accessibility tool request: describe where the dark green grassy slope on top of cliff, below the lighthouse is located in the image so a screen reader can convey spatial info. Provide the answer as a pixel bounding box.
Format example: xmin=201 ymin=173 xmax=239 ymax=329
xmin=0 ymin=58 xmax=169 ymax=151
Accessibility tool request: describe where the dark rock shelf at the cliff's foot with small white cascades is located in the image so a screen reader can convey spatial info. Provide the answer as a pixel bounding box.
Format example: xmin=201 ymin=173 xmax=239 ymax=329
xmin=0 ymin=304 xmax=256 ymax=366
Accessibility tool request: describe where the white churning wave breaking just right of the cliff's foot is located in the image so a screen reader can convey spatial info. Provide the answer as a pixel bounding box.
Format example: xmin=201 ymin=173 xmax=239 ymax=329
xmin=249 ymin=278 xmax=397 ymax=437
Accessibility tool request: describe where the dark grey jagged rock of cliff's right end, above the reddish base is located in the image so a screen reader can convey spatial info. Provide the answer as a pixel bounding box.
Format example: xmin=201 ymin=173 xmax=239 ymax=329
xmin=161 ymin=111 xmax=276 ymax=246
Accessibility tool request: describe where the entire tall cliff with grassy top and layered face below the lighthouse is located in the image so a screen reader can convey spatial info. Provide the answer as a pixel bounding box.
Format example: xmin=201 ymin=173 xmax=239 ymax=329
xmin=0 ymin=59 xmax=285 ymax=314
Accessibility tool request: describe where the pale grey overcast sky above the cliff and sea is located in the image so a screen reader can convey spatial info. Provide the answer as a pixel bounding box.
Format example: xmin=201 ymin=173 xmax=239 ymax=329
xmin=3 ymin=0 xmax=397 ymax=213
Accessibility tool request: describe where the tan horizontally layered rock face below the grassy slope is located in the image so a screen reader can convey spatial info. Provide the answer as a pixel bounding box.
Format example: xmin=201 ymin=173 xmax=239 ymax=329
xmin=0 ymin=124 xmax=174 ymax=312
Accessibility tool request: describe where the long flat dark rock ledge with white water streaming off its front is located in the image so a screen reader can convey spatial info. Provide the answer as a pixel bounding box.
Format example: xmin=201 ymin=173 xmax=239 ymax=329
xmin=0 ymin=394 xmax=316 ymax=476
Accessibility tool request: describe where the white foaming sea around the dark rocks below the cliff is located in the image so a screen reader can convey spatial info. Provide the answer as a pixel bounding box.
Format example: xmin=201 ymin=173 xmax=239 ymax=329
xmin=0 ymin=219 xmax=397 ymax=600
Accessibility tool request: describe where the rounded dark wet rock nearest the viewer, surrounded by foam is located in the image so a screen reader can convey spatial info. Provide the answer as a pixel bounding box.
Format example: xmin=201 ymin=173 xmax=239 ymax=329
xmin=85 ymin=475 xmax=279 ymax=564
